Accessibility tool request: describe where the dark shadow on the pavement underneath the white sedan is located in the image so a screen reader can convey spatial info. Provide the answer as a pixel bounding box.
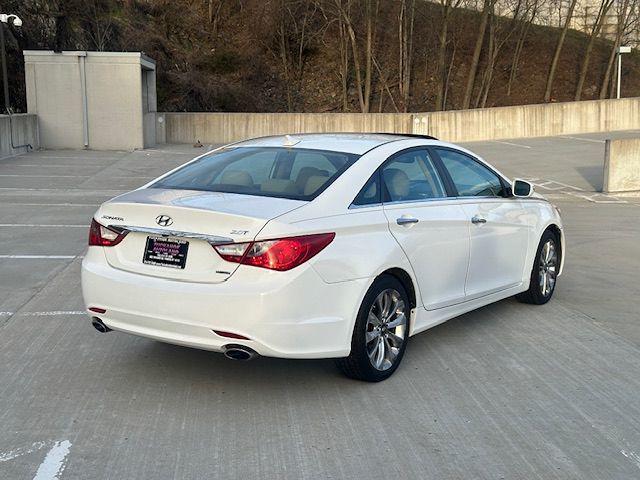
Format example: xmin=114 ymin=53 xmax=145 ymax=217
xmin=112 ymin=299 xmax=526 ymax=390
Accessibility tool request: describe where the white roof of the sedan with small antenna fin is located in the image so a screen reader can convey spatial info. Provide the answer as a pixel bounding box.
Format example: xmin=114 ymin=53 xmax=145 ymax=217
xmin=228 ymin=133 xmax=435 ymax=155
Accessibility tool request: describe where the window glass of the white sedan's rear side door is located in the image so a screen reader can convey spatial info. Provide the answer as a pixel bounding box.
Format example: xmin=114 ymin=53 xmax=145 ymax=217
xmin=382 ymin=150 xmax=446 ymax=202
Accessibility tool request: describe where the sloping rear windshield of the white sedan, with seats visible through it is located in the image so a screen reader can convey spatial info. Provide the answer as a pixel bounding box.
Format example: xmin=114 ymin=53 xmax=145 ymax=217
xmin=151 ymin=147 xmax=359 ymax=200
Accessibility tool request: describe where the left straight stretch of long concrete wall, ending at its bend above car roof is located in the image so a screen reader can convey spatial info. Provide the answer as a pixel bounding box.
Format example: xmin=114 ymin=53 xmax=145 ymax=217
xmin=165 ymin=113 xmax=412 ymax=143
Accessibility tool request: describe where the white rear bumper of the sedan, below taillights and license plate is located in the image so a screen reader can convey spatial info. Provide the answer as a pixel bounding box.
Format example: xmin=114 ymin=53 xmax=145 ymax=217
xmin=82 ymin=247 xmax=368 ymax=358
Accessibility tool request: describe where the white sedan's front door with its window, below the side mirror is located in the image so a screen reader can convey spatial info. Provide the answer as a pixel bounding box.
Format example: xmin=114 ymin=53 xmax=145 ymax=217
xmin=434 ymin=147 xmax=529 ymax=300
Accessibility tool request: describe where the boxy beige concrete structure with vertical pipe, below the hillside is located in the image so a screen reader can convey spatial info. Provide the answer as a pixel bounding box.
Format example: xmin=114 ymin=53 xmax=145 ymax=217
xmin=24 ymin=50 xmax=157 ymax=150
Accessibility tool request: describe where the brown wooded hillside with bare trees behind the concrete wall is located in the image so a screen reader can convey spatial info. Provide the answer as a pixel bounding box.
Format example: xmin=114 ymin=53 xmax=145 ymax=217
xmin=3 ymin=0 xmax=640 ymax=112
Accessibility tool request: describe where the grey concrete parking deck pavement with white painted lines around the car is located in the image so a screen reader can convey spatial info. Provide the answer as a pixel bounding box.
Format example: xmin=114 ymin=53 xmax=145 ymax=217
xmin=0 ymin=133 xmax=640 ymax=480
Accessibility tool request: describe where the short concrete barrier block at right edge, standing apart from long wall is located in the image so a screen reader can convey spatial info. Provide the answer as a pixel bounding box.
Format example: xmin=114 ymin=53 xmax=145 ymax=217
xmin=602 ymin=138 xmax=640 ymax=192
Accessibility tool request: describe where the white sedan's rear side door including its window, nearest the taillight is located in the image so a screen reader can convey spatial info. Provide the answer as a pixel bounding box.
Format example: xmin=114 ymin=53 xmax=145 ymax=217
xmin=381 ymin=148 xmax=469 ymax=310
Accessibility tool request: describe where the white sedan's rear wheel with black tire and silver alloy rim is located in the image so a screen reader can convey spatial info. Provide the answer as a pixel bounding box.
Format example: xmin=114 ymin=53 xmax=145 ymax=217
xmin=336 ymin=275 xmax=411 ymax=382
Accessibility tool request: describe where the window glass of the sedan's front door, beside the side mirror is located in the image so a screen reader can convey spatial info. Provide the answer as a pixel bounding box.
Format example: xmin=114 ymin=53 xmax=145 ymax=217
xmin=436 ymin=148 xmax=503 ymax=197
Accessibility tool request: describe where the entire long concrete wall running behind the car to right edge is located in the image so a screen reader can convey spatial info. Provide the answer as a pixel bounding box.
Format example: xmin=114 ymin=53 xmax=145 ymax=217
xmin=157 ymin=98 xmax=640 ymax=143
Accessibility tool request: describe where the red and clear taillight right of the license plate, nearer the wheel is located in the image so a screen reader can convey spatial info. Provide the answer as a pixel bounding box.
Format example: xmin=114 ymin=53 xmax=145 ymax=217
xmin=213 ymin=233 xmax=336 ymax=271
